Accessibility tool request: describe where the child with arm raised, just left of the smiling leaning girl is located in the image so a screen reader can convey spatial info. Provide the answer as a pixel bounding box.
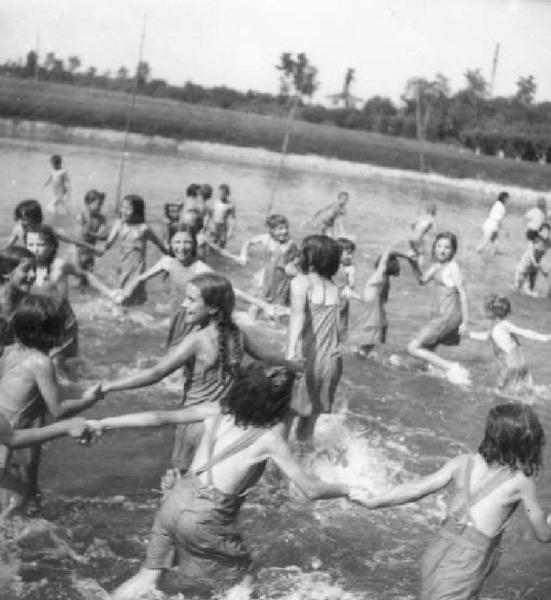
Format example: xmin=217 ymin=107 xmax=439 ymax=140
xmin=358 ymin=252 xmax=400 ymax=358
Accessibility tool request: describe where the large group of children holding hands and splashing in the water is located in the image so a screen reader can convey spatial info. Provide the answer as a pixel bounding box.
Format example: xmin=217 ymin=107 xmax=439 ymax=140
xmin=0 ymin=158 xmax=551 ymax=600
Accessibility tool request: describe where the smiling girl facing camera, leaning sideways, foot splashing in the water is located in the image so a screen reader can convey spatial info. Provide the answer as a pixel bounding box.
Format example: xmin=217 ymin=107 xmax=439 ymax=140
xmin=408 ymin=232 xmax=469 ymax=380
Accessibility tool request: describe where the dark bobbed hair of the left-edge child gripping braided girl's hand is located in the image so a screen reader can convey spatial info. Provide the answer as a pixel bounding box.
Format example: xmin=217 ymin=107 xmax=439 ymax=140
xmin=10 ymin=294 xmax=63 ymax=354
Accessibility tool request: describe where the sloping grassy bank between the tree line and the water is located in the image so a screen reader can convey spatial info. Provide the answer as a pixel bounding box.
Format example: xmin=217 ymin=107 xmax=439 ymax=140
xmin=0 ymin=77 xmax=550 ymax=190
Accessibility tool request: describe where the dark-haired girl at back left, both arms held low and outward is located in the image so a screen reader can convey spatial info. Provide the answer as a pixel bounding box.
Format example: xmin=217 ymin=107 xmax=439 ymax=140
xmin=100 ymin=194 xmax=169 ymax=306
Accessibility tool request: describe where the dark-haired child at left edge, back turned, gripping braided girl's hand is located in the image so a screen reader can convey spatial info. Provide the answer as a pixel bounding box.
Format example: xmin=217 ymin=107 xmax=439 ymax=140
xmin=0 ymin=295 xmax=100 ymax=510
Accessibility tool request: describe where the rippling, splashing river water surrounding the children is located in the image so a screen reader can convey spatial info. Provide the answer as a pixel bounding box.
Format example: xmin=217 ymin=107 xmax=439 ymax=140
xmin=0 ymin=144 xmax=551 ymax=600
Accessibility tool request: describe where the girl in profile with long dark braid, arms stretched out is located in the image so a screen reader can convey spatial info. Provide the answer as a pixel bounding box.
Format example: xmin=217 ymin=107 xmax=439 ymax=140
xmin=95 ymin=273 xmax=301 ymax=472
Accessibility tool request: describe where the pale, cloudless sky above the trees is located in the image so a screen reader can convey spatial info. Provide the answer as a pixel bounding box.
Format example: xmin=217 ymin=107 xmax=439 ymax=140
xmin=0 ymin=0 xmax=551 ymax=103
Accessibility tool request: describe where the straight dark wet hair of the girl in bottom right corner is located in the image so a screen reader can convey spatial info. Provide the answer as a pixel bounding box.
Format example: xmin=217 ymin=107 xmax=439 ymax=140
xmin=478 ymin=402 xmax=545 ymax=477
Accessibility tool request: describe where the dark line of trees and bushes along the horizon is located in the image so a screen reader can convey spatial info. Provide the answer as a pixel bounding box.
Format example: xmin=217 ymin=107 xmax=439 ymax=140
xmin=0 ymin=51 xmax=551 ymax=163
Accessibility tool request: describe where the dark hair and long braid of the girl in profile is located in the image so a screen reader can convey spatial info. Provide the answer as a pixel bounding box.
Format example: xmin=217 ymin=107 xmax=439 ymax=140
xmin=189 ymin=273 xmax=243 ymax=381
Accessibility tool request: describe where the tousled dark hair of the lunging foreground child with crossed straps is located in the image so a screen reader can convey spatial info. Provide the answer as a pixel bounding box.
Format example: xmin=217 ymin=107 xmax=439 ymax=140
xmin=220 ymin=363 xmax=295 ymax=427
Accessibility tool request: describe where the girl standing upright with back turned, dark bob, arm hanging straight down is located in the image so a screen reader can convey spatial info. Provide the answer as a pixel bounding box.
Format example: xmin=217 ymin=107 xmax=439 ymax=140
xmin=287 ymin=235 xmax=342 ymax=441
